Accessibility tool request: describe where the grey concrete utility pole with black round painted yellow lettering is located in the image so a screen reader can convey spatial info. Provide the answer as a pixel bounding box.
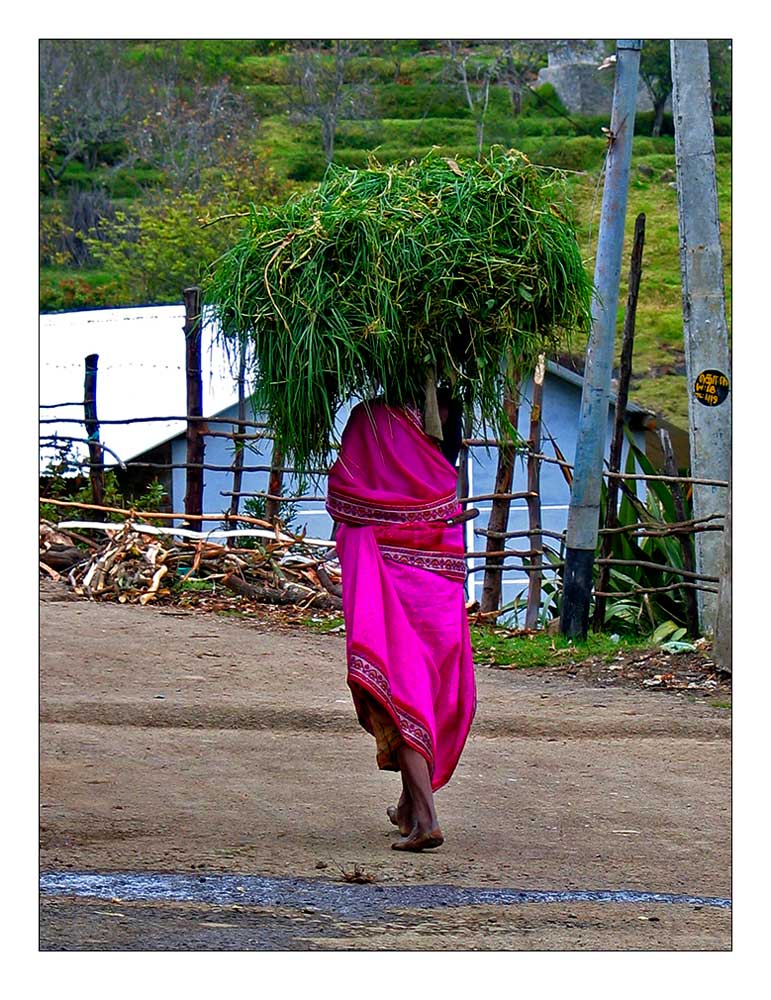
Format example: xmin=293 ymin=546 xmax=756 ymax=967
xmin=670 ymin=39 xmax=731 ymax=632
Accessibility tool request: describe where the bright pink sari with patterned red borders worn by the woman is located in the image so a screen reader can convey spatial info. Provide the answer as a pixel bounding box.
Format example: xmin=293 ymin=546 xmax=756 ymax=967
xmin=327 ymin=401 xmax=476 ymax=790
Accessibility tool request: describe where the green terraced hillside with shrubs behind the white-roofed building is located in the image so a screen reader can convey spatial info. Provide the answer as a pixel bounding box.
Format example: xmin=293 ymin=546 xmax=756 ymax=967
xmin=41 ymin=40 xmax=731 ymax=426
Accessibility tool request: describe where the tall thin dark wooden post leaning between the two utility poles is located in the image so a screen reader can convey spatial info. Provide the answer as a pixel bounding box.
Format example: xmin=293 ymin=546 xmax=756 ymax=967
xmin=592 ymin=212 xmax=648 ymax=632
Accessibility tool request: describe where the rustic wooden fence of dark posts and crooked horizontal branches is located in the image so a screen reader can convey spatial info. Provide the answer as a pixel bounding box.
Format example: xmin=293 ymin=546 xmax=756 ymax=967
xmin=40 ymin=289 xmax=728 ymax=635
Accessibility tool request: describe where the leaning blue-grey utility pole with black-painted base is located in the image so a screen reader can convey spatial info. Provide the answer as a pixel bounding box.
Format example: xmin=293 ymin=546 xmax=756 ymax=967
xmin=560 ymin=39 xmax=642 ymax=639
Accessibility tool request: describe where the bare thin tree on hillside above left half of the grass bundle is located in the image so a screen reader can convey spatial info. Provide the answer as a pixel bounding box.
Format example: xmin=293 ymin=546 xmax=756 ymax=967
xmin=290 ymin=39 xmax=369 ymax=163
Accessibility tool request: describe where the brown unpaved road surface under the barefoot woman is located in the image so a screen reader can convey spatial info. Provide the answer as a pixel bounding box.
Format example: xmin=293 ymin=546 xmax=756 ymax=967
xmin=40 ymin=592 xmax=731 ymax=951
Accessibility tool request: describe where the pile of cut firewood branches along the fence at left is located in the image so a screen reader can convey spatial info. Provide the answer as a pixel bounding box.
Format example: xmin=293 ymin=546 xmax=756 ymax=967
xmin=40 ymin=520 xmax=342 ymax=610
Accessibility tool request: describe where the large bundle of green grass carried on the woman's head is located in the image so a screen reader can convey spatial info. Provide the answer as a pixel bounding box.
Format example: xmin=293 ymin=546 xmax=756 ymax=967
xmin=205 ymin=148 xmax=592 ymax=467
